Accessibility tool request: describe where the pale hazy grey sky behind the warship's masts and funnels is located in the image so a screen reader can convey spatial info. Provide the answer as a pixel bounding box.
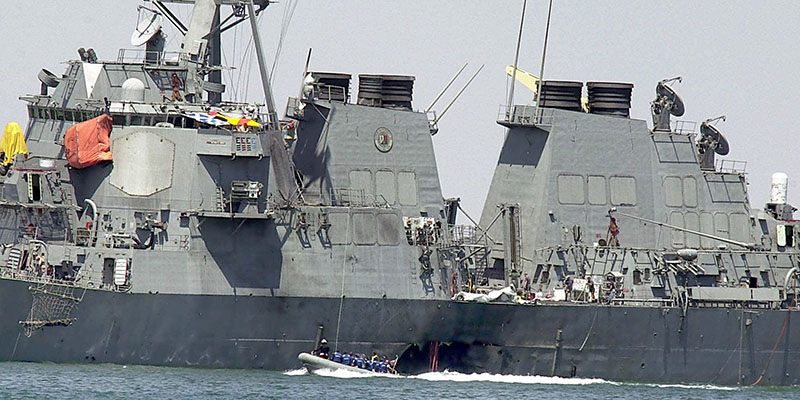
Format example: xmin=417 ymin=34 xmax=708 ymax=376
xmin=0 ymin=0 xmax=800 ymax=219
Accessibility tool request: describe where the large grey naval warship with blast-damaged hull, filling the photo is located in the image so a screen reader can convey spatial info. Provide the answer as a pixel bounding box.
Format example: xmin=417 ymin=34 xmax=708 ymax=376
xmin=0 ymin=0 xmax=800 ymax=385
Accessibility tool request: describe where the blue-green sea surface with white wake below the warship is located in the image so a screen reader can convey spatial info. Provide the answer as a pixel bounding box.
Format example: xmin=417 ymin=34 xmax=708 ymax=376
xmin=0 ymin=362 xmax=800 ymax=400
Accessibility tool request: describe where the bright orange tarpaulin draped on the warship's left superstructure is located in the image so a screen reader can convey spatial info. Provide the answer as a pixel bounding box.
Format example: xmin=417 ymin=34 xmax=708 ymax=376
xmin=64 ymin=115 xmax=112 ymax=168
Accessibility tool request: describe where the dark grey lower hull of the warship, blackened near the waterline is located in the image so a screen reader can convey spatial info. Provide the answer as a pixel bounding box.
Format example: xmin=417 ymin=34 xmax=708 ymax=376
xmin=0 ymin=279 xmax=800 ymax=385
